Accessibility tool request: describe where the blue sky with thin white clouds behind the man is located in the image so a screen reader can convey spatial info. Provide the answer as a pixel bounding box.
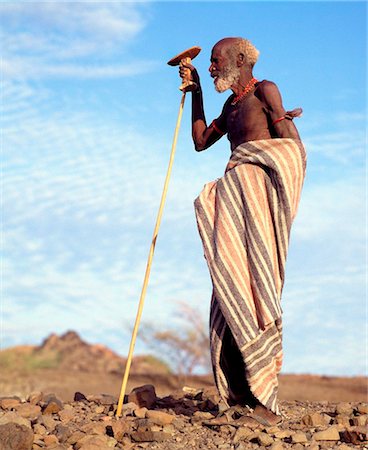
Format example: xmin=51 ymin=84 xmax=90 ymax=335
xmin=0 ymin=1 xmax=367 ymax=375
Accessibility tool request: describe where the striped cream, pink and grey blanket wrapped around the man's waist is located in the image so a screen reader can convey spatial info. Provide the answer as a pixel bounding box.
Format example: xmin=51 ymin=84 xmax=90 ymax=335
xmin=195 ymin=139 xmax=306 ymax=413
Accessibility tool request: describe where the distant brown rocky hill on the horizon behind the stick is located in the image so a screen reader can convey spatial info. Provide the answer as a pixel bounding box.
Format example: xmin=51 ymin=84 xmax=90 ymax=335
xmin=0 ymin=331 xmax=170 ymax=374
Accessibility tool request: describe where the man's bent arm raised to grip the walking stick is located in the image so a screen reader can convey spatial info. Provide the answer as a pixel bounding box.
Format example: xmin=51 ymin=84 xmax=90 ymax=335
xmin=179 ymin=64 xmax=226 ymax=152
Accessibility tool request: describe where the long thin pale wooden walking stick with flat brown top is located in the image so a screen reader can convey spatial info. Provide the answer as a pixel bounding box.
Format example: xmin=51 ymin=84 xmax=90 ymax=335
xmin=116 ymin=47 xmax=201 ymax=417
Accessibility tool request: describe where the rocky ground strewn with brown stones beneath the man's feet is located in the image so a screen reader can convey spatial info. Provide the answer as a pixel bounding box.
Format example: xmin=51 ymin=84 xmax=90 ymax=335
xmin=0 ymin=385 xmax=368 ymax=450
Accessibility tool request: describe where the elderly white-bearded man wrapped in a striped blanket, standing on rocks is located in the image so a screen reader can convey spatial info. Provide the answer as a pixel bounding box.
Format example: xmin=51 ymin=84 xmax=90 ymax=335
xmin=180 ymin=38 xmax=306 ymax=425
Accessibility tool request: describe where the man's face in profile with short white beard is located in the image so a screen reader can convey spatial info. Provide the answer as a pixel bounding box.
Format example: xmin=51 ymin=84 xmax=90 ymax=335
xmin=209 ymin=45 xmax=240 ymax=92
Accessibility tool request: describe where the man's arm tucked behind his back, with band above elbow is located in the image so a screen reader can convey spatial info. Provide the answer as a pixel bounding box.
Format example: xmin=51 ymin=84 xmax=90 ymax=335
xmin=259 ymin=81 xmax=302 ymax=140
